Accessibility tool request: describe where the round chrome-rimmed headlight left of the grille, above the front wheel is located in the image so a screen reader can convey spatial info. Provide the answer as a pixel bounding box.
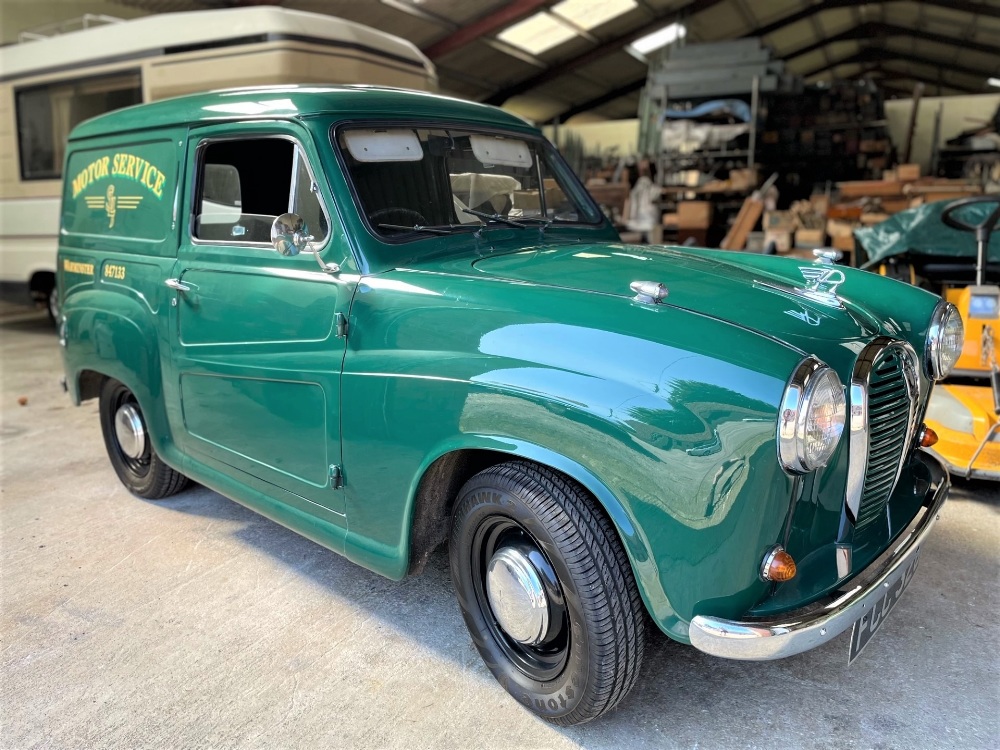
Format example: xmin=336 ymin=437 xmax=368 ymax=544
xmin=778 ymin=357 xmax=847 ymax=473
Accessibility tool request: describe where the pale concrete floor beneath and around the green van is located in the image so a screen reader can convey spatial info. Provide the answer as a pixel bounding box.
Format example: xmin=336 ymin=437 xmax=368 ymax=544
xmin=0 ymin=306 xmax=1000 ymax=750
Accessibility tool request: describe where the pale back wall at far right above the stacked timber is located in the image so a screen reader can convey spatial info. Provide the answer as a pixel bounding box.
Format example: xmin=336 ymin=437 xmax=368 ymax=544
xmin=885 ymin=94 xmax=1000 ymax=174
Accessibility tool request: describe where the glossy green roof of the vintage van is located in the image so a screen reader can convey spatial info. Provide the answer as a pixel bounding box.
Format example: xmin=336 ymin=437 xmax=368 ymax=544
xmin=70 ymin=85 xmax=530 ymax=140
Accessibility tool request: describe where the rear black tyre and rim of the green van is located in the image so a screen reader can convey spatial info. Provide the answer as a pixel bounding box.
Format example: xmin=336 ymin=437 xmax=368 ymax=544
xmin=100 ymin=379 xmax=188 ymax=500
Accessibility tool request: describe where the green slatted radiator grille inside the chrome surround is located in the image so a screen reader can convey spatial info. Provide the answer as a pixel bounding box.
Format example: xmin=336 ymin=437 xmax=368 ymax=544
xmin=855 ymin=346 xmax=913 ymax=529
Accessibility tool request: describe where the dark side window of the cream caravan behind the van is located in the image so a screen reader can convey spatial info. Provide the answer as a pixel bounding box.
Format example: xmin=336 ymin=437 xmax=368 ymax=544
xmin=16 ymin=71 xmax=142 ymax=180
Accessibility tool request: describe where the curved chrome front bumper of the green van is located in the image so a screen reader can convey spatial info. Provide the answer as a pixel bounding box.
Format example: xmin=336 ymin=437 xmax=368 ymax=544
xmin=688 ymin=453 xmax=950 ymax=661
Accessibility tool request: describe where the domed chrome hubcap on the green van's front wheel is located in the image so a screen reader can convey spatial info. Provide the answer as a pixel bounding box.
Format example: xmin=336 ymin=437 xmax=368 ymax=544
xmin=486 ymin=547 xmax=549 ymax=646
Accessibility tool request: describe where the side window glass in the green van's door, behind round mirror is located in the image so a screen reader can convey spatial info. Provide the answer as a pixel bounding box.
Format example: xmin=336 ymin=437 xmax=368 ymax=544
xmin=194 ymin=138 xmax=329 ymax=245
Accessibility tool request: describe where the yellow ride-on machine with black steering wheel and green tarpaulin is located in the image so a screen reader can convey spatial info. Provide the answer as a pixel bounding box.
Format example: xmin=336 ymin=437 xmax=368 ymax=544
xmin=855 ymin=195 xmax=1000 ymax=480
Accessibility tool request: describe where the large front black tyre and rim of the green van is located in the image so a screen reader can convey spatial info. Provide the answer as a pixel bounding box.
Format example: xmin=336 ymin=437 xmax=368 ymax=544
xmin=450 ymin=462 xmax=645 ymax=726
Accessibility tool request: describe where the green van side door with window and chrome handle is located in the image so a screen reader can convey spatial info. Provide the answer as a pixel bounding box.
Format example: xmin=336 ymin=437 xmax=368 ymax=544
xmin=165 ymin=124 xmax=356 ymax=525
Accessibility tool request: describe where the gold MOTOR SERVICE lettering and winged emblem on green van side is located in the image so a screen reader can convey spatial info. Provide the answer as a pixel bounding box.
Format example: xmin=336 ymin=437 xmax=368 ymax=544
xmin=72 ymin=152 xmax=166 ymax=229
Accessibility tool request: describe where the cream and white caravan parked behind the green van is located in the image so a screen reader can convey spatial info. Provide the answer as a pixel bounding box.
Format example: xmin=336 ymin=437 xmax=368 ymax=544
xmin=0 ymin=7 xmax=437 ymax=320
